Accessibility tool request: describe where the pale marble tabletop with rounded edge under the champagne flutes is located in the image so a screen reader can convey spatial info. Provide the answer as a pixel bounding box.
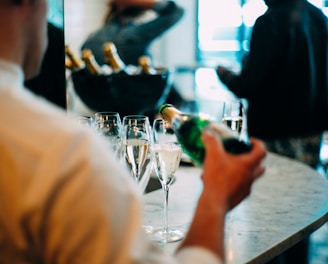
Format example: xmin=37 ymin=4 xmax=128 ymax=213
xmin=144 ymin=154 xmax=328 ymax=264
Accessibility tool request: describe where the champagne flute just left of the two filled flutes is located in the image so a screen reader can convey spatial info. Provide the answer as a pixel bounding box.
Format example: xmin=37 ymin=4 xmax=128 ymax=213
xmin=94 ymin=112 xmax=122 ymax=159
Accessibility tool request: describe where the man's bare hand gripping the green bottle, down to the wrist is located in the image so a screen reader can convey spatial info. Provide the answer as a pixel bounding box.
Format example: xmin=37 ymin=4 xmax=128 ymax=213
xmin=202 ymin=131 xmax=266 ymax=211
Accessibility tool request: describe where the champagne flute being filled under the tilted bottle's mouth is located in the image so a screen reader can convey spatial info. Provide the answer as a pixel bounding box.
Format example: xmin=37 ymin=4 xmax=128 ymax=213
xmin=152 ymin=119 xmax=184 ymax=243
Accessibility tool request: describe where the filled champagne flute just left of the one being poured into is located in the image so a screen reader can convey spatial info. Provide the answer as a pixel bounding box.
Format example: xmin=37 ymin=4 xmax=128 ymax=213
xmin=122 ymin=115 xmax=152 ymax=192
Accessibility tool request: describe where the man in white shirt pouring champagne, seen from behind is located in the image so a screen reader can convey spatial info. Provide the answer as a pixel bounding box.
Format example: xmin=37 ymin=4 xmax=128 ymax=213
xmin=0 ymin=0 xmax=266 ymax=264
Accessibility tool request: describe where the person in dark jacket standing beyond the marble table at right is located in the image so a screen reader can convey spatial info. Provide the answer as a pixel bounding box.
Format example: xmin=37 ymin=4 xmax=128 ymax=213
xmin=217 ymin=0 xmax=328 ymax=264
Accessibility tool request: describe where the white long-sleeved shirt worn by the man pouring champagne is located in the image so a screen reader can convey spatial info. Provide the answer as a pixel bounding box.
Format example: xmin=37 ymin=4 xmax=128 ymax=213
xmin=0 ymin=60 xmax=223 ymax=264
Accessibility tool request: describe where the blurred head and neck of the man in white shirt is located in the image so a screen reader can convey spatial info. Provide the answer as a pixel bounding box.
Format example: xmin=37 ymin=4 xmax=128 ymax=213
xmin=0 ymin=0 xmax=48 ymax=79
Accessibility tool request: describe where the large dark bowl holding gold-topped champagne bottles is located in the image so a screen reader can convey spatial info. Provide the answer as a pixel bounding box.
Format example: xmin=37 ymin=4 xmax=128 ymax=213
xmin=72 ymin=69 xmax=172 ymax=116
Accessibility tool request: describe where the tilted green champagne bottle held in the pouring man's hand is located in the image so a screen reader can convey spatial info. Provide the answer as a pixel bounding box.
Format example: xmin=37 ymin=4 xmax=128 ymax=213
xmin=159 ymin=104 xmax=252 ymax=166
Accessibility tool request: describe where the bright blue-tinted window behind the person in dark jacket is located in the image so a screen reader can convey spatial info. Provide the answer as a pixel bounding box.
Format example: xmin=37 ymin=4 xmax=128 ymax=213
xmin=197 ymin=0 xmax=328 ymax=66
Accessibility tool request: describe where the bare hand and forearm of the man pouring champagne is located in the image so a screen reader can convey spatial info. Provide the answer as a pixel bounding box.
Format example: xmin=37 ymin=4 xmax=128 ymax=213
xmin=178 ymin=130 xmax=266 ymax=260
